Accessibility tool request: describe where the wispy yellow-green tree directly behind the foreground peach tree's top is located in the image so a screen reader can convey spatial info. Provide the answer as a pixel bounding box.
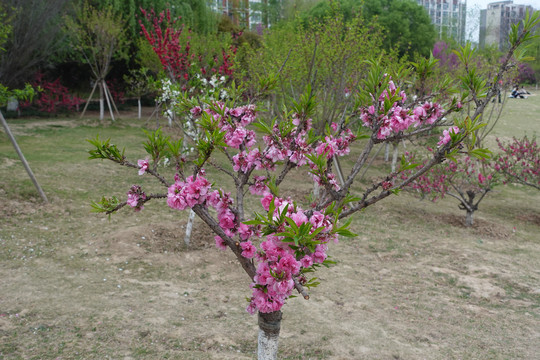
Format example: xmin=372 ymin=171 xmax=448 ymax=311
xmin=235 ymin=6 xmax=388 ymax=132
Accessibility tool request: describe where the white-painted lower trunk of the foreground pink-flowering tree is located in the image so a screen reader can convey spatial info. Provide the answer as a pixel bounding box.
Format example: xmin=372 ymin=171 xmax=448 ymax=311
xmin=257 ymin=311 xmax=282 ymax=360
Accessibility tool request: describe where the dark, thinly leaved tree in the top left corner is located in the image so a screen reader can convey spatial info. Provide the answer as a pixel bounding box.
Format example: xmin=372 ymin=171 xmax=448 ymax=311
xmin=0 ymin=0 xmax=69 ymax=87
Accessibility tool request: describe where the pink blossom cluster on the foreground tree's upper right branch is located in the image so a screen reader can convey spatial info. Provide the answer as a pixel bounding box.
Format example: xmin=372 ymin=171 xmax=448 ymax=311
xmin=360 ymin=80 xmax=442 ymax=139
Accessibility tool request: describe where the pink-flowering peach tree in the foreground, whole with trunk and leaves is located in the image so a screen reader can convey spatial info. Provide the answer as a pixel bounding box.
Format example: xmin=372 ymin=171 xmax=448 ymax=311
xmin=90 ymin=11 xmax=536 ymax=359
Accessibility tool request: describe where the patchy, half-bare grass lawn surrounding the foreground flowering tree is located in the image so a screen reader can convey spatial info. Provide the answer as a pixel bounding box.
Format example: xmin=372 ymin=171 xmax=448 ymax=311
xmin=0 ymin=95 xmax=540 ymax=359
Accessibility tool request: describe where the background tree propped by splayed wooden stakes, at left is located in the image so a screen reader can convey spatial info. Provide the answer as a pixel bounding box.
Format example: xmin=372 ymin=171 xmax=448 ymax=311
xmin=66 ymin=2 xmax=126 ymax=120
